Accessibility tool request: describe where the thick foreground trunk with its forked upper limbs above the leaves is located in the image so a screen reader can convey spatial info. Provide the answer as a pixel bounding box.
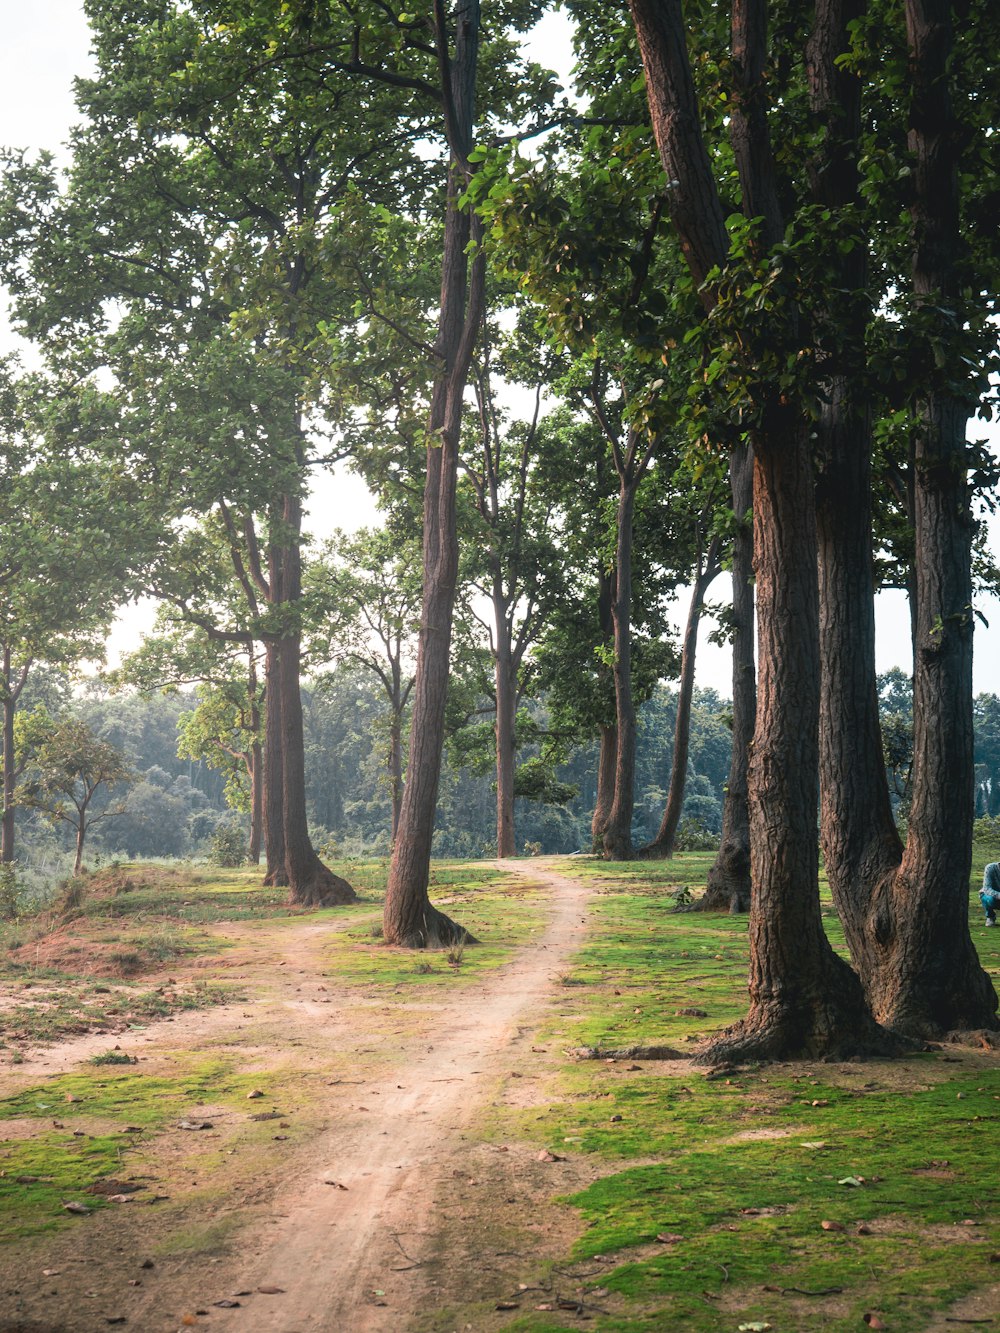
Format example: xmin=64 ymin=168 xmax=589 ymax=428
xmin=631 ymin=0 xmax=893 ymax=1061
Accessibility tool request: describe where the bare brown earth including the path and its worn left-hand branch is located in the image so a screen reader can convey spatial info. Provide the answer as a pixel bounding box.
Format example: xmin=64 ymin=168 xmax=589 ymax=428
xmin=0 ymin=862 xmax=610 ymax=1333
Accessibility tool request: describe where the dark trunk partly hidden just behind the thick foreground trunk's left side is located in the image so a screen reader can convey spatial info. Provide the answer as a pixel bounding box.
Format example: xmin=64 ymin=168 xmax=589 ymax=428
xmin=697 ymin=444 xmax=757 ymax=912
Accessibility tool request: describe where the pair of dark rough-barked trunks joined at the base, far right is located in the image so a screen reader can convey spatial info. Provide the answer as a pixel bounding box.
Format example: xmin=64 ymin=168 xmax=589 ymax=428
xmin=811 ymin=0 xmax=996 ymax=1037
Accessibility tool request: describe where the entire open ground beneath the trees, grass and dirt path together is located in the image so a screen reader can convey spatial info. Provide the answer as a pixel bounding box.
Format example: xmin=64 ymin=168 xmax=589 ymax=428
xmin=0 ymin=854 xmax=1000 ymax=1333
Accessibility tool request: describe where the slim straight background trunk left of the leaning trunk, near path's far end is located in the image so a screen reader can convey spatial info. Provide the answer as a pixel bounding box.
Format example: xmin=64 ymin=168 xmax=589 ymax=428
xmin=604 ymin=476 xmax=636 ymax=861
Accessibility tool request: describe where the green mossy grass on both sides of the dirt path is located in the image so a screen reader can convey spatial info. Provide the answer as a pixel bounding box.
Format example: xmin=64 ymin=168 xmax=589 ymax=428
xmin=0 ymin=853 xmax=1000 ymax=1333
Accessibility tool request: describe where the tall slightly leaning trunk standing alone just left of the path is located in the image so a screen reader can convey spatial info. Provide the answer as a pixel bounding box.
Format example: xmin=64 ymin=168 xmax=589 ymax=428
xmin=383 ymin=0 xmax=484 ymax=948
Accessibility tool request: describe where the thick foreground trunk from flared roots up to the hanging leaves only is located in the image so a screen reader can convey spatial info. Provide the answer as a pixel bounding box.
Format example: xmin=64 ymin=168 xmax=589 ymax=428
xmin=705 ymin=408 xmax=896 ymax=1061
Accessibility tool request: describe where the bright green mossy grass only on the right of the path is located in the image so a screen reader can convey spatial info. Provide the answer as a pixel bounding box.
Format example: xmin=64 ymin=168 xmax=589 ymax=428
xmin=491 ymin=853 xmax=1000 ymax=1333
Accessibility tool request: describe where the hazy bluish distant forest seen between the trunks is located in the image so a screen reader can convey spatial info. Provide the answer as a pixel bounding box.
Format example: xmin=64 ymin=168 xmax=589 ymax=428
xmin=17 ymin=665 xmax=1000 ymax=873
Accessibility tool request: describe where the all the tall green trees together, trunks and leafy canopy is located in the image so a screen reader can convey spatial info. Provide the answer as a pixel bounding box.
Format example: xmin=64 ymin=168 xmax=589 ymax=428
xmin=0 ymin=0 xmax=1000 ymax=1060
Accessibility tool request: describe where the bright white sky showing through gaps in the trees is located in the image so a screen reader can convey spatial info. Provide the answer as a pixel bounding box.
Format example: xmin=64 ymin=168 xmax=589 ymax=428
xmin=0 ymin=0 xmax=1000 ymax=694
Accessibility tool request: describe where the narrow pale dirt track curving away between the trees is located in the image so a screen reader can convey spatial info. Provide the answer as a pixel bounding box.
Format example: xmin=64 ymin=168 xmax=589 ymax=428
xmin=213 ymin=866 xmax=587 ymax=1333
